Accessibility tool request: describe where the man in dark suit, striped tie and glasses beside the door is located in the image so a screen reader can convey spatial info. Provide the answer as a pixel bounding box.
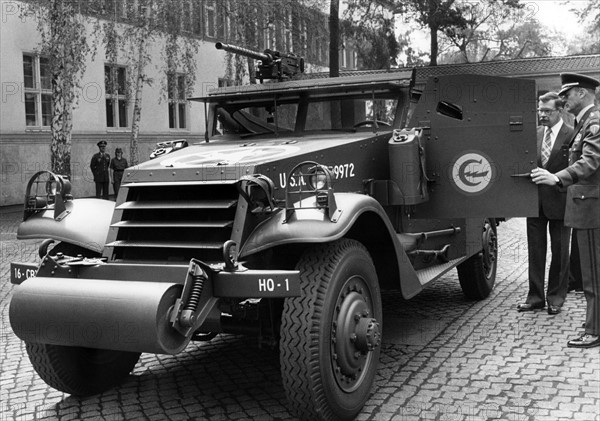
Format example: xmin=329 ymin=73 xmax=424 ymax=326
xmin=517 ymin=92 xmax=573 ymax=314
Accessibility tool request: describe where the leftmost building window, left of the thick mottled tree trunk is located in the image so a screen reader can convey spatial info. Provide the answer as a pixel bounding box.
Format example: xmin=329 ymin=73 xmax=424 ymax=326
xmin=23 ymin=54 xmax=52 ymax=127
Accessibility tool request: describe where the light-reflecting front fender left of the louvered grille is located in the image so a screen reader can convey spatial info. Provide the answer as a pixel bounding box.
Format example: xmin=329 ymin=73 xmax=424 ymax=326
xmin=17 ymin=199 xmax=115 ymax=253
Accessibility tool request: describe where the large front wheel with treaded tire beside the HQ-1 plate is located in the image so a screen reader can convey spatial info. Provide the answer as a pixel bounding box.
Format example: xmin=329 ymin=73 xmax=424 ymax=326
xmin=280 ymin=239 xmax=382 ymax=420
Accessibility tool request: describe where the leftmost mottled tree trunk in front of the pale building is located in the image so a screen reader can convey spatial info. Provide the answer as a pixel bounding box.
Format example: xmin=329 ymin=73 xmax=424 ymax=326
xmin=24 ymin=0 xmax=91 ymax=177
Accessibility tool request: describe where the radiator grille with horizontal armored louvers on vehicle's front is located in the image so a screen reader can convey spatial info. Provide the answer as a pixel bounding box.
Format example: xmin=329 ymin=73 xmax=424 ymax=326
xmin=106 ymin=183 xmax=238 ymax=262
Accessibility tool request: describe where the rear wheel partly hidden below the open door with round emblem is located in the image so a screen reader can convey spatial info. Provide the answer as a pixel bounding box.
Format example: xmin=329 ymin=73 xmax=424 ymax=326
xmin=457 ymin=218 xmax=498 ymax=300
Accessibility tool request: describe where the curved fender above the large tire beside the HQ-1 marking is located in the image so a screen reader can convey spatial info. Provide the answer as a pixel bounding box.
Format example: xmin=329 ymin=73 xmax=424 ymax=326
xmin=240 ymin=193 xmax=423 ymax=298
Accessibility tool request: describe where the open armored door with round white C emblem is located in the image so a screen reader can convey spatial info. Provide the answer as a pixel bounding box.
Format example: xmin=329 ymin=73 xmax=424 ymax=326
xmin=409 ymin=75 xmax=538 ymax=218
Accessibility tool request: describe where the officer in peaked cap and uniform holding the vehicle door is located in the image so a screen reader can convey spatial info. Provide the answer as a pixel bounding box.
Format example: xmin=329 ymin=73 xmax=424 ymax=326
xmin=531 ymin=73 xmax=600 ymax=348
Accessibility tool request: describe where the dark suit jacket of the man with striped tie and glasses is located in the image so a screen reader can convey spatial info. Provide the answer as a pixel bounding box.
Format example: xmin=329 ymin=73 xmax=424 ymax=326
xmin=537 ymin=123 xmax=573 ymax=219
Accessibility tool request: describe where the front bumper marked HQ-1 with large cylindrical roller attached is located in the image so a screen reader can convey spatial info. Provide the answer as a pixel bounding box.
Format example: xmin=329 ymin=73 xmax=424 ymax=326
xmin=9 ymin=257 xmax=300 ymax=354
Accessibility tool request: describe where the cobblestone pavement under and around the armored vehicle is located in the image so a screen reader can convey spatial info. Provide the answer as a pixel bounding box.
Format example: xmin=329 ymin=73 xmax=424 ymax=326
xmin=0 ymin=209 xmax=600 ymax=421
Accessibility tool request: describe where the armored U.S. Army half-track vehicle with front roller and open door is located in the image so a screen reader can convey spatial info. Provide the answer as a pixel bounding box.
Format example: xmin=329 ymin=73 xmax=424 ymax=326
xmin=10 ymin=67 xmax=537 ymax=420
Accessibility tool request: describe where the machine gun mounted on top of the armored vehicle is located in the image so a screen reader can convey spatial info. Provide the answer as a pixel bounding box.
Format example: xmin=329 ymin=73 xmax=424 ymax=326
xmin=215 ymin=42 xmax=304 ymax=82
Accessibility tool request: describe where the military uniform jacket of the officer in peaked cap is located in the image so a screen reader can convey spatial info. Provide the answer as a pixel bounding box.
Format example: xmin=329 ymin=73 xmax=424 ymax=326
xmin=556 ymin=106 xmax=600 ymax=229
